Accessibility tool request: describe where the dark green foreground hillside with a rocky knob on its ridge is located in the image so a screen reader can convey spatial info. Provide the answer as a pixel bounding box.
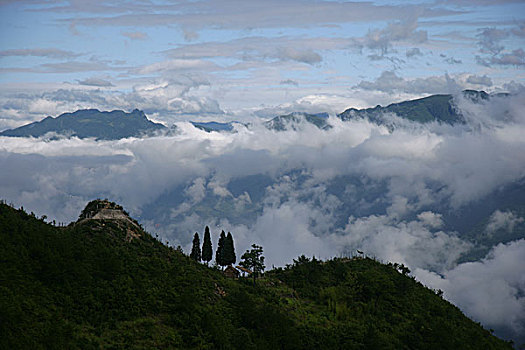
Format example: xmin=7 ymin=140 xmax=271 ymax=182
xmin=0 ymin=200 xmax=512 ymax=349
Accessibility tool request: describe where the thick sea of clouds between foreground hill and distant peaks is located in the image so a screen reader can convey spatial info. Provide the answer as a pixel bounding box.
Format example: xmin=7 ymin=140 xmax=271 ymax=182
xmin=0 ymin=91 xmax=525 ymax=342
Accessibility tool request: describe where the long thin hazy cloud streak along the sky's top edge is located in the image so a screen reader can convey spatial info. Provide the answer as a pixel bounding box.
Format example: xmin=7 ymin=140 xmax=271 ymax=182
xmin=50 ymin=0 xmax=454 ymax=32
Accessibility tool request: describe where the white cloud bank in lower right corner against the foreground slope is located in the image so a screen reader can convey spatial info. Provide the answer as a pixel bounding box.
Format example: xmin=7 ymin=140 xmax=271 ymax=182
xmin=414 ymin=239 xmax=525 ymax=341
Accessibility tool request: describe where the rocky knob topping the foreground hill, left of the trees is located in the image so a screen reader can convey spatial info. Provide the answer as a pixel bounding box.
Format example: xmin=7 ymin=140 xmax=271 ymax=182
xmin=75 ymin=199 xmax=144 ymax=242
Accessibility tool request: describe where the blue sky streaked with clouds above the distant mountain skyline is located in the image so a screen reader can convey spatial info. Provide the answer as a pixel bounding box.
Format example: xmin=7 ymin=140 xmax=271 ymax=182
xmin=0 ymin=0 xmax=525 ymax=129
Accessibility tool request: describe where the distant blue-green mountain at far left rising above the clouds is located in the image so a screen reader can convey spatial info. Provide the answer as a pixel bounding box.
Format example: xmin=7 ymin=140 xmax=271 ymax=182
xmin=0 ymin=109 xmax=166 ymax=140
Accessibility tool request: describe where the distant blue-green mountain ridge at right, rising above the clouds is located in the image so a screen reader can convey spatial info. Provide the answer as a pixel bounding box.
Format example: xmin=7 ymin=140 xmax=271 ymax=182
xmin=338 ymin=90 xmax=490 ymax=124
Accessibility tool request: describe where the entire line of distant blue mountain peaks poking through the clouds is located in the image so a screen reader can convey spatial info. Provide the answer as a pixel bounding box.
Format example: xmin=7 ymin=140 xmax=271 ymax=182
xmin=0 ymin=90 xmax=504 ymax=140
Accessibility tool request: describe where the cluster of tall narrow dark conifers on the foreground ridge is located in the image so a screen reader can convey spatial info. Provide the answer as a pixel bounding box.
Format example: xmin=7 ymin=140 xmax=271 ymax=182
xmin=190 ymin=226 xmax=237 ymax=266
